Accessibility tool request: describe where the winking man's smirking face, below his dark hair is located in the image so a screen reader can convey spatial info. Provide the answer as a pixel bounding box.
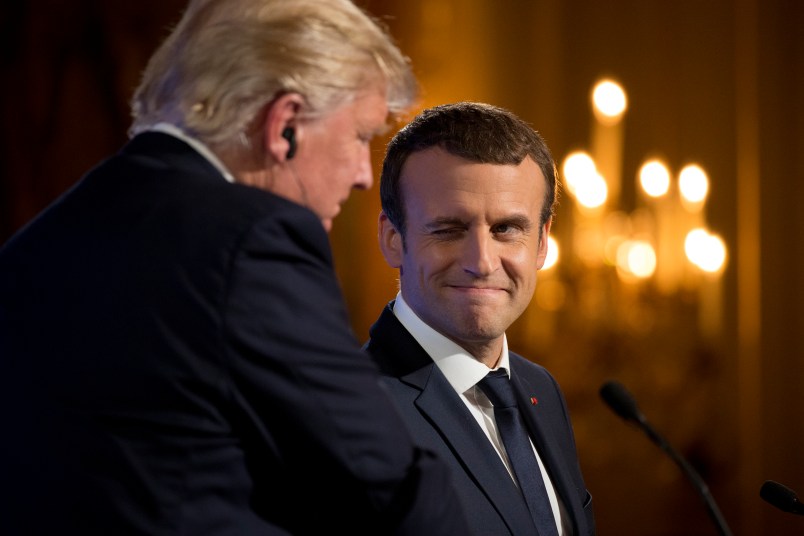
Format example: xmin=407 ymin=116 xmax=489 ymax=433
xmin=400 ymin=148 xmax=546 ymax=364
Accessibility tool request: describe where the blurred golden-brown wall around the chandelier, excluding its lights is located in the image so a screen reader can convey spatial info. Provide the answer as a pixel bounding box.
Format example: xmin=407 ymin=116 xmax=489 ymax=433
xmin=332 ymin=0 xmax=804 ymax=535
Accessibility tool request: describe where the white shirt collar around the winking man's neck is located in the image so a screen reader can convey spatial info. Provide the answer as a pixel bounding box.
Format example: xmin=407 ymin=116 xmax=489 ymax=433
xmin=393 ymin=292 xmax=511 ymax=394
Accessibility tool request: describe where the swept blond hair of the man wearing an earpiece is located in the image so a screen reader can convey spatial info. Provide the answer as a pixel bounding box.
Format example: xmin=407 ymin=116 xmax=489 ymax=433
xmin=131 ymin=0 xmax=417 ymax=146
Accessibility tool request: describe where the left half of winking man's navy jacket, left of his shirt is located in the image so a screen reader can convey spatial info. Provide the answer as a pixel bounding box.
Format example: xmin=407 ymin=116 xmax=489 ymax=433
xmin=365 ymin=305 xmax=533 ymax=536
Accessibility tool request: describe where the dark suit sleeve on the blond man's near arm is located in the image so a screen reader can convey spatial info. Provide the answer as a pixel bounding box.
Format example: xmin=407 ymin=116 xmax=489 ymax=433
xmin=223 ymin=210 xmax=472 ymax=534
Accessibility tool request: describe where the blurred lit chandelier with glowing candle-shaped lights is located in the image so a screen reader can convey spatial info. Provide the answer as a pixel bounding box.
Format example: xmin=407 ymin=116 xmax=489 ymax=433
xmin=542 ymin=79 xmax=728 ymax=342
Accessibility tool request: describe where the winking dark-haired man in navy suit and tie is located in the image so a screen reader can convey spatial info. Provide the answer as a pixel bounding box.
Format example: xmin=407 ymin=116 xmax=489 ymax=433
xmin=366 ymin=103 xmax=595 ymax=536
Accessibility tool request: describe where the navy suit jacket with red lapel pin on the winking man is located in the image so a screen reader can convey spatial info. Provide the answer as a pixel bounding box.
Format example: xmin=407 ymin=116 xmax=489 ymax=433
xmin=365 ymin=304 xmax=595 ymax=536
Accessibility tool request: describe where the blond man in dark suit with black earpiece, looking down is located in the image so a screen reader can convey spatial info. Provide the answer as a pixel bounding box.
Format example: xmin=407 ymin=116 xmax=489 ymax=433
xmin=0 ymin=0 xmax=468 ymax=535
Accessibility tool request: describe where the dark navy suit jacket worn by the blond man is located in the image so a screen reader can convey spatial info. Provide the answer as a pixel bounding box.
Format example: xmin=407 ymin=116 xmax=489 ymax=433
xmin=0 ymin=133 xmax=466 ymax=536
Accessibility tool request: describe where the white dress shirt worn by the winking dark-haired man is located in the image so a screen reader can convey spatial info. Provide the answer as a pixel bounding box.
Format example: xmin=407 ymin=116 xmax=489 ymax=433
xmin=393 ymin=293 xmax=571 ymax=536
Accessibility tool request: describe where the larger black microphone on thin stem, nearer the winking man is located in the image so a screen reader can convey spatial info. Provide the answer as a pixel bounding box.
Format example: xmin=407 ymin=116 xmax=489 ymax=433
xmin=600 ymin=381 xmax=731 ymax=536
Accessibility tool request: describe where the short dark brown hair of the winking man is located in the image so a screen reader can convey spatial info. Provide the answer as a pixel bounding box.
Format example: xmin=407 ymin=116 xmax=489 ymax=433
xmin=380 ymin=102 xmax=558 ymax=239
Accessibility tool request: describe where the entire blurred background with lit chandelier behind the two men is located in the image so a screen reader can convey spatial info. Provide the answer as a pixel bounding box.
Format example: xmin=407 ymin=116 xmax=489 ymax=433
xmin=0 ymin=0 xmax=804 ymax=536
